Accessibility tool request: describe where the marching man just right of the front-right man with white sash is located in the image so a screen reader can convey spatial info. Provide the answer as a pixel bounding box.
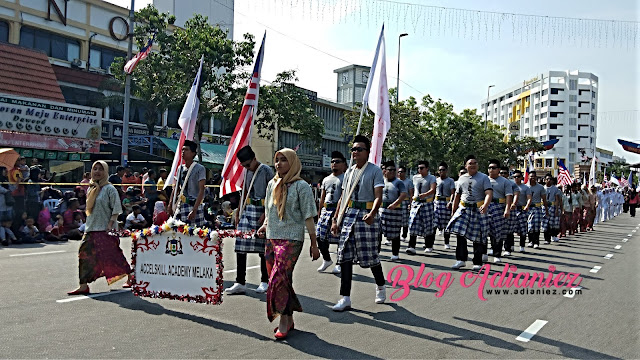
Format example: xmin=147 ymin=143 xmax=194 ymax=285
xmin=487 ymin=159 xmax=513 ymax=263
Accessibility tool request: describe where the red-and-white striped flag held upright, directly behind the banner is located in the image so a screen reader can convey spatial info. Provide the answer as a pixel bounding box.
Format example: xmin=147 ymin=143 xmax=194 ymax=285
xmin=220 ymin=32 xmax=267 ymax=197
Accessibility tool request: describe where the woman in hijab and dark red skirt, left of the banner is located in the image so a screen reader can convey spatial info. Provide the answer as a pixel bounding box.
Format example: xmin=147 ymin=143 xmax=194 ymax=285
xmin=67 ymin=161 xmax=131 ymax=295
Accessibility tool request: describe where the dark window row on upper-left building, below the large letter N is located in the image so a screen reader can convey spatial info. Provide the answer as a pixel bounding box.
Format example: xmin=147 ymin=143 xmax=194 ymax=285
xmin=20 ymin=27 xmax=80 ymax=61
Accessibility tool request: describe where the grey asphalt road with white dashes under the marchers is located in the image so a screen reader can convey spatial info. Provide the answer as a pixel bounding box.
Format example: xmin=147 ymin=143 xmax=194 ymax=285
xmin=0 ymin=214 xmax=640 ymax=359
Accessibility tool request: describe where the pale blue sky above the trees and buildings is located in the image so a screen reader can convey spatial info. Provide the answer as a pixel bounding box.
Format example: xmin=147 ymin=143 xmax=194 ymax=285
xmin=108 ymin=0 xmax=640 ymax=162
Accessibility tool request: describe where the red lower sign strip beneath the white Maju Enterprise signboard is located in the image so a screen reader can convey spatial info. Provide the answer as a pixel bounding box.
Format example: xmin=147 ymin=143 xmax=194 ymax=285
xmin=0 ymin=131 xmax=100 ymax=153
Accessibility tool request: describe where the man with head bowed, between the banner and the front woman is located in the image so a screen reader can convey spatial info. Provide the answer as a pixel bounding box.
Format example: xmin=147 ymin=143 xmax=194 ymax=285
xmin=225 ymin=146 xmax=273 ymax=295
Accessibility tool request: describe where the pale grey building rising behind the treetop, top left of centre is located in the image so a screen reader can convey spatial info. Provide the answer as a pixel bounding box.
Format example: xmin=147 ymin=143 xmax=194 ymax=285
xmin=153 ymin=0 xmax=235 ymax=39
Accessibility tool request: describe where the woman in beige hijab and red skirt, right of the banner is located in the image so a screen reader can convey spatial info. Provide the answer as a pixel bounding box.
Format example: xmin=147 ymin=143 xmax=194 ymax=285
xmin=258 ymin=148 xmax=320 ymax=340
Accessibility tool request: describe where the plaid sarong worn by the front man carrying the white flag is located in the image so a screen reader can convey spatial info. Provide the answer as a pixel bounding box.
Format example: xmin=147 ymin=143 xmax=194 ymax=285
xmin=338 ymin=208 xmax=380 ymax=268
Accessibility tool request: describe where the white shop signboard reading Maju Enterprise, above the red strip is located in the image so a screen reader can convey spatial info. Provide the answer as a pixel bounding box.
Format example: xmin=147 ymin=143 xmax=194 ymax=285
xmin=0 ymin=94 xmax=102 ymax=140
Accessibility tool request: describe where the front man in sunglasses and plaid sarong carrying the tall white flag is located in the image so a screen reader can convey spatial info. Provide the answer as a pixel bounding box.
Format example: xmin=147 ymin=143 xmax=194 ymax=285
xmin=331 ymin=135 xmax=387 ymax=311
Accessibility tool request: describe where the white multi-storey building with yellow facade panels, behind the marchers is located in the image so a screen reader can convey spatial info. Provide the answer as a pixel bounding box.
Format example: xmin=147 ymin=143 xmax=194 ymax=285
xmin=480 ymin=70 xmax=598 ymax=173
